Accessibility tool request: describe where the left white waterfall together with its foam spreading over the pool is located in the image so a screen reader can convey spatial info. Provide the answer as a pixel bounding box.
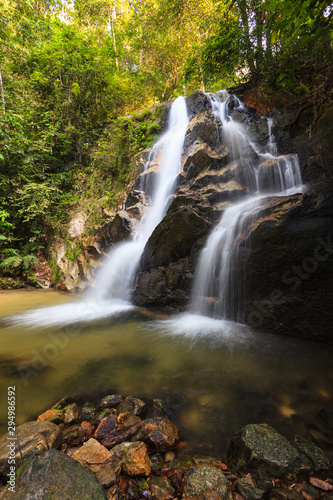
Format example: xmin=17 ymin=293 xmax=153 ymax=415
xmin=13 ymin=97 xmax=189 ymax=326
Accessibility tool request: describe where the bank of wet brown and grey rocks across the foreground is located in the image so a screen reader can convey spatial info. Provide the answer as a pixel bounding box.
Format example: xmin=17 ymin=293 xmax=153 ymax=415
xmin=0 ymin=394 xmax=333 ymax=500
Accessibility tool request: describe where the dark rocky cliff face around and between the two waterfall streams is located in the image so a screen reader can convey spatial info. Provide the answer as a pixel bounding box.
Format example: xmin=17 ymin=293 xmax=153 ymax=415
xmin=52 ymin=92 xmax=333 ymax=341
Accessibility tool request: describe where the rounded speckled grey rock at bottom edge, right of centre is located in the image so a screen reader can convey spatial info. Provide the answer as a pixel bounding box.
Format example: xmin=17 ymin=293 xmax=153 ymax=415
xmin=184 ymin=467 xmax=232 ymax=500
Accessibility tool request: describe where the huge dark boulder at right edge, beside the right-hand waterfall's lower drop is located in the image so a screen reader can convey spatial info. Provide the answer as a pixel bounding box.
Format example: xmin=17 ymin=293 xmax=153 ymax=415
xmin=238 ymin=183 xmax=333 ymax=342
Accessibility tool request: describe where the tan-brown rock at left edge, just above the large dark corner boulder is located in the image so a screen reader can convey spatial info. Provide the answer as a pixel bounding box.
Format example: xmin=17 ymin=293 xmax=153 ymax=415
xmin=0 ymin=422 xmax=62 ymax=471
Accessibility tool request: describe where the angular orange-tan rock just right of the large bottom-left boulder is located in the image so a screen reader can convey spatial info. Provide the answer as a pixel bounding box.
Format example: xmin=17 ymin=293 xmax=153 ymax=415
xmin=72 ymin=439 xmax=121 ymax=488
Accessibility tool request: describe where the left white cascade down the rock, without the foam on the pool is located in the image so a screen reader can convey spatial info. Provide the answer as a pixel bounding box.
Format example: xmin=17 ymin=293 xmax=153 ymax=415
xmin=89 ymin=97 xmax=188 ymax=301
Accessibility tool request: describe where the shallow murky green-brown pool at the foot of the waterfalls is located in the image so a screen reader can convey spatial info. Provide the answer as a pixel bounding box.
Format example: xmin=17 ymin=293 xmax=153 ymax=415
xmin=0 ymin=290 xmax=333 ymax=456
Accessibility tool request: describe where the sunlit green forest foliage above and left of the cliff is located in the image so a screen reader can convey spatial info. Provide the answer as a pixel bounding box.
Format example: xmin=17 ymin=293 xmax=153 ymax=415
xmin=0 ymin=0 xmax=333 ymax=290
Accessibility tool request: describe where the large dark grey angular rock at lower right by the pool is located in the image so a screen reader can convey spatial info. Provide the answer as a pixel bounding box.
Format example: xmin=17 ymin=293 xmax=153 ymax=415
xmin=228 ymin=424 xmax=311 ymax=477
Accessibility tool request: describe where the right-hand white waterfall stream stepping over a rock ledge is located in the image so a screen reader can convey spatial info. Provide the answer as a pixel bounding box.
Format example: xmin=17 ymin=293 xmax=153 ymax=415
xmin=190 ymin=91 xmax=303 ymax=321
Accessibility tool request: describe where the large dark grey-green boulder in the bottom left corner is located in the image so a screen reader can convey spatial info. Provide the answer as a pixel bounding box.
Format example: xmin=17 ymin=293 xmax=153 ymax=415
xmin=0 ymin=450 xmax=106 ymax=500
